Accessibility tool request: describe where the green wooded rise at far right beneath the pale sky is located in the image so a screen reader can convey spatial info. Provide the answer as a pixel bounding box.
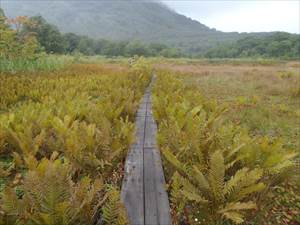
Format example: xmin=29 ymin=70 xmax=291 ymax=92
xmin=204 ymin=32 xmax=300 ymax=59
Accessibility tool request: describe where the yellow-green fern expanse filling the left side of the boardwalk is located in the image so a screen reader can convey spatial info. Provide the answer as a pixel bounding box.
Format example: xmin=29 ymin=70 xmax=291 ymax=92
xmin=0 ymin=60 xmax=151 ymax=225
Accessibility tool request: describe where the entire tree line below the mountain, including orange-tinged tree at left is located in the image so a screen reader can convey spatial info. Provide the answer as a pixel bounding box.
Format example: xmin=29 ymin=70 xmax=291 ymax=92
xmin=0 ymin=9 xmax=300 ymax=59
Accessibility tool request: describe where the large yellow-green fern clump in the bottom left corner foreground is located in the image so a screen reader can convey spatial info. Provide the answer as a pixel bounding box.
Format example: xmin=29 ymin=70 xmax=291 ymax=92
xmin=1 ymin=159 xmax=104 ymax=225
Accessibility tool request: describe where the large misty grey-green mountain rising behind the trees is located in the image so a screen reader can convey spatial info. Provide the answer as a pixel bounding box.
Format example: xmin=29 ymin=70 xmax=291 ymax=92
xmin=1 ymin=0 xmax=270 ymax=52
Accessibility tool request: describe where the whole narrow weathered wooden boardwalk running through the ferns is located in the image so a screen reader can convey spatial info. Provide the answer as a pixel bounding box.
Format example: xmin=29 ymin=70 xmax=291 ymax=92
xmin=121 ymin=78 xmax=172 ymax=225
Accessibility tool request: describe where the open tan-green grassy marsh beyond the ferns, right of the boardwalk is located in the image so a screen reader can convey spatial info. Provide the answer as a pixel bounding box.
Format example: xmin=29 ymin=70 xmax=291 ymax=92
xmin=158 ymin=62 xmax=300 ymax=149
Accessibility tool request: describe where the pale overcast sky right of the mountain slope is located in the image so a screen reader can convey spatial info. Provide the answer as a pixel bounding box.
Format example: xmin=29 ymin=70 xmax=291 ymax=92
xmin=163 ymin=0 xmax=300 ymax=33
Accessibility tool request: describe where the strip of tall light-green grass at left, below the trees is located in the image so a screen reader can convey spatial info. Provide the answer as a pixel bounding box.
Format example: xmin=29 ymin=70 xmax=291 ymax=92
xmin=0 ymin=54 xmax=74 ymax=73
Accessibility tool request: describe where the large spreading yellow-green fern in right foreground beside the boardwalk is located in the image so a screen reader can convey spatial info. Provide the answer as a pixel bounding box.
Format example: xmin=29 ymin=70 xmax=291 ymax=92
xmin=163 ymin=151 xmax=264 ymax=224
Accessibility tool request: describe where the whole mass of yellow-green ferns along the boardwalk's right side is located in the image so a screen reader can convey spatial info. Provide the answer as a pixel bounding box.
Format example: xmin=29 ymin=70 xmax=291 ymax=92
xmin=153 ymin=71 xmax=298 ymax=224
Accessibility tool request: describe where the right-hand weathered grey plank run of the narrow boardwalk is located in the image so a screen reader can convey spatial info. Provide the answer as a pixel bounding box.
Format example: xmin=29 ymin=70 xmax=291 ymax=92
xmin=144 ymin=84 xmax=172 ymax=225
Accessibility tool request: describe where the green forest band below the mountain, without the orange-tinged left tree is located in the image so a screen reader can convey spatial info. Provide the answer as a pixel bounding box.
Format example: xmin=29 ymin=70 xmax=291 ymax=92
xmin=0 ymin=9 xmax=300 ymax=59
